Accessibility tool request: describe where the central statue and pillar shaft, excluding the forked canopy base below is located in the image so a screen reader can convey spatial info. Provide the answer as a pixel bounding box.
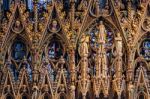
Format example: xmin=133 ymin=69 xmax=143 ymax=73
xmin=96 ymin=21 xmax=107 ymax=77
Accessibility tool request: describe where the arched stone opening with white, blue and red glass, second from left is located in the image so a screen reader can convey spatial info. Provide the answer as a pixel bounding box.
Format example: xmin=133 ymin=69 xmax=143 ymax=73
xmin=42 ymin=33 xmax=69 ymax=72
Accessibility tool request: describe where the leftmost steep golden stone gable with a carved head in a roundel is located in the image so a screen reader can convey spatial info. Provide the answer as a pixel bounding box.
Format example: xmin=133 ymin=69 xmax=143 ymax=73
xmin=2 ymin=5 xmax=31 ymax=50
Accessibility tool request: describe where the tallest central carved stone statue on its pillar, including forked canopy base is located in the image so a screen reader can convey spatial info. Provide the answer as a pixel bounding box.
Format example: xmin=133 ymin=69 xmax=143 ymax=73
xmin=93 ymin=21 xmax=110 ymax=98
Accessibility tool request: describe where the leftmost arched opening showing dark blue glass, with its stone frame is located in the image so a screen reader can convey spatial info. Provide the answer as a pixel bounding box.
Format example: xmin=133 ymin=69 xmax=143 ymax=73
xmin=2 ymin=35 xmax=32 ymax=80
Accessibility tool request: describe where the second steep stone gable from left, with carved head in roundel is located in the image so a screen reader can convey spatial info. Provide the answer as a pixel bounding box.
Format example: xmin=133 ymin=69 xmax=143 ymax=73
xmin=40 ymin=3 xmax=70 ymax=47
